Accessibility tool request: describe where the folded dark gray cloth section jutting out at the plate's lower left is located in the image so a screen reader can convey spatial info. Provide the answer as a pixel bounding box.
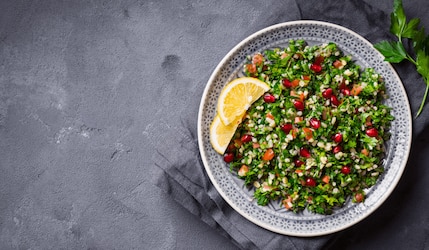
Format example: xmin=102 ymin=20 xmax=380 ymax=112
xmin=148 ymin=120 xmax=328 ymax=249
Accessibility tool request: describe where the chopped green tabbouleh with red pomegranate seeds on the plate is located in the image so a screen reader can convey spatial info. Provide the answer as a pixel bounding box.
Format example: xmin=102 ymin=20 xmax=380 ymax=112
xmin=224 ymin=40 xmax=394 ymax=214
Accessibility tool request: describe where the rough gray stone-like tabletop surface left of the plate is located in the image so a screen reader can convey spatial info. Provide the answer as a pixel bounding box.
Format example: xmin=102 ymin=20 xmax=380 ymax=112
xmin=0 ymin=0 xmax=427 ymax=249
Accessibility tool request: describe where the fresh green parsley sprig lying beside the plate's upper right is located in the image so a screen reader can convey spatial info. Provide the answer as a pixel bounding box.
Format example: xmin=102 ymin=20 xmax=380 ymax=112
xmin=374 ymin=0 xmax=429 ymax=117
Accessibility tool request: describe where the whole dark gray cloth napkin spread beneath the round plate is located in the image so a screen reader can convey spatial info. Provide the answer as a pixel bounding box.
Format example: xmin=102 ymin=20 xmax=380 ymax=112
xmin=149 ymin=0 xmax=427 ymax=249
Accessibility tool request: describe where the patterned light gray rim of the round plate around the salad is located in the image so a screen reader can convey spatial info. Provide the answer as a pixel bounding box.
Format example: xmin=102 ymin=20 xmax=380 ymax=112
xmin=198 ymin=21 xmax=412 ymax=236
